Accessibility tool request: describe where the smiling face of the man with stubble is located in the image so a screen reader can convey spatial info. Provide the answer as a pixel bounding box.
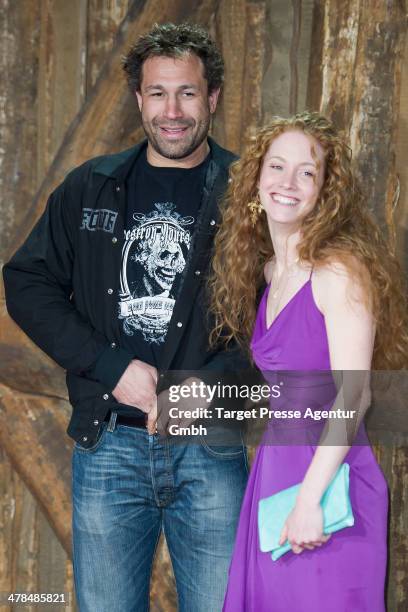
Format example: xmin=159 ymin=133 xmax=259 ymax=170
xmin=136 ymin=54 xmax=219 ymax=159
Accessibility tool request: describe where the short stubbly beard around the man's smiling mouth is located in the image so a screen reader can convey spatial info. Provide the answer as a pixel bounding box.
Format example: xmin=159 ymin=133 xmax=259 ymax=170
xmin=142 ymin=113 xmax=210 ymax=159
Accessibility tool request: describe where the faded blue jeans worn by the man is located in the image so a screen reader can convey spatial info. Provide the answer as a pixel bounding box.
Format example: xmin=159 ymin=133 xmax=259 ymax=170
xmin=72 ymin=415 xmax=248 ymax=612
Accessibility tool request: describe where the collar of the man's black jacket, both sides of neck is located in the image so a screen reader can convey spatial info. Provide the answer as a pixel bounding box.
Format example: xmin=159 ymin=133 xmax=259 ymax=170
xmin=94 ymin=137 xmax=238 ymax=182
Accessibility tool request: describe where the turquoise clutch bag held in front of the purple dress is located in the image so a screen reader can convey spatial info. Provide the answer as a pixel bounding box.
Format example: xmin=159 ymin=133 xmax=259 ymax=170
xmin=258 ymin=463 xmax=354 ymax=561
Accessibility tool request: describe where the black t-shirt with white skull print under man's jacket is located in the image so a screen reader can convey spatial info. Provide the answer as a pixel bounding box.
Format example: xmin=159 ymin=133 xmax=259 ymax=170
xmin=119 ymin=149 xmax=209 ymax=367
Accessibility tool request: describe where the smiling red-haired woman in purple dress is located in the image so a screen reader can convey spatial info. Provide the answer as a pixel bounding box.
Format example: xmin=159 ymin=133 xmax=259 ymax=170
xmin=211 ymin=113 xmax=408 ymax=612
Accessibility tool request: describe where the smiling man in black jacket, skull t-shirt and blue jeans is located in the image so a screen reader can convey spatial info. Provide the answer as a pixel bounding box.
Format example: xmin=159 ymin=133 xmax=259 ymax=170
xmin=4 ymin=24 xmax=247 ymax=612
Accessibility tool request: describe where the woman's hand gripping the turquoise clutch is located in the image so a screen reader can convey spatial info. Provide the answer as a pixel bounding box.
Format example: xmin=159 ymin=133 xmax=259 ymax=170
xmin=279 ymin=501 xmax=330 ymax=554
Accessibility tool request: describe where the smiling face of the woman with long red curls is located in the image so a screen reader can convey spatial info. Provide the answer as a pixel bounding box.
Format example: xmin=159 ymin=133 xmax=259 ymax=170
xmin=259 ymin=130 xmax=325 ymax=229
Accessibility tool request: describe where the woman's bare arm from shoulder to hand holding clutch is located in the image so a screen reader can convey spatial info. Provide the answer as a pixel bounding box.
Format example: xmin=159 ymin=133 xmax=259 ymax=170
xmin=281 ymin=264 xmax=375 ymax=553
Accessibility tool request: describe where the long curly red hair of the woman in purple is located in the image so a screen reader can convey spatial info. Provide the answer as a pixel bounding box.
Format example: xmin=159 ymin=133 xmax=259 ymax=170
xmin=210 ymin=112 xmax=408 ymax=369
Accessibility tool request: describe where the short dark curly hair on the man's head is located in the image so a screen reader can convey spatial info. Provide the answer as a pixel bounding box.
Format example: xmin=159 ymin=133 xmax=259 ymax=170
xmin=122 ymin=23 xmax=224 ymax=93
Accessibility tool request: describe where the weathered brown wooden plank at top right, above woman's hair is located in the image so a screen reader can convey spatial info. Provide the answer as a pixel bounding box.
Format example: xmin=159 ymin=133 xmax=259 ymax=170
xmin=350 ymin=0 xmax=407 ymax=237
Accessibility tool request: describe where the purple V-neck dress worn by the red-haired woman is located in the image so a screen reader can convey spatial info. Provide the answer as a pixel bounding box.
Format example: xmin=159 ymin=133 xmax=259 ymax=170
xmin=223 ymin=279 xmax=388 ymax=612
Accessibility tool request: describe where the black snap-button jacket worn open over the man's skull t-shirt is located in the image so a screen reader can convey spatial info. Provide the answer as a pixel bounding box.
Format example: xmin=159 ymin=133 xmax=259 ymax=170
xmin=3 ymin=139 xmax=247 ymax=448
